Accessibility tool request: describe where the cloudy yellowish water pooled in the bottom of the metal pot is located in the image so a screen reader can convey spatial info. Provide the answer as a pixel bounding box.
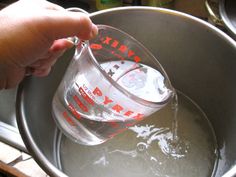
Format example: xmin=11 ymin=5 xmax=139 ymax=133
xmin=56 ymin=92 xmax=218 ymax=177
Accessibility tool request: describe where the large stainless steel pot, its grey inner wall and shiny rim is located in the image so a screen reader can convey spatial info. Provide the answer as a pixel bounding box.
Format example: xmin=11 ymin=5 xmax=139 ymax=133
xmin=17 ymin=7 xmax=236 ymax=177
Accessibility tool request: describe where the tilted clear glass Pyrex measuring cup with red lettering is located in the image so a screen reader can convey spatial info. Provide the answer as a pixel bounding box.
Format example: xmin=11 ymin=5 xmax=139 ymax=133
xmin=52 ymin=25 xmax=173 ymax=145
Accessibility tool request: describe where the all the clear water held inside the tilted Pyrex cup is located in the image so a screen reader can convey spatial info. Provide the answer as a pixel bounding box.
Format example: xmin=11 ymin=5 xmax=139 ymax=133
xmin=53 ymin=61 xmax=172 ymax=145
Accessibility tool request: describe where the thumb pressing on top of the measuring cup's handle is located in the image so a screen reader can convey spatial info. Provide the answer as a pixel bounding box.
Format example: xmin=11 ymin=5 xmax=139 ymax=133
xmin=42 ymin=10 xmax=98 ymax=40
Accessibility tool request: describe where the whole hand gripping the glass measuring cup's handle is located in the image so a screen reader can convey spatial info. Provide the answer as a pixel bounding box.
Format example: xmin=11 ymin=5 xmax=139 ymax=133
xmin=0 ymin=0 xmax=97 ymax=89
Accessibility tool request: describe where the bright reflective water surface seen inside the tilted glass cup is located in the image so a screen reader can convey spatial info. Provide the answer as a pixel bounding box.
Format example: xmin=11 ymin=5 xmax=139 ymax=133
xmin=101 ymin=61 xmax=172 ymax=103
